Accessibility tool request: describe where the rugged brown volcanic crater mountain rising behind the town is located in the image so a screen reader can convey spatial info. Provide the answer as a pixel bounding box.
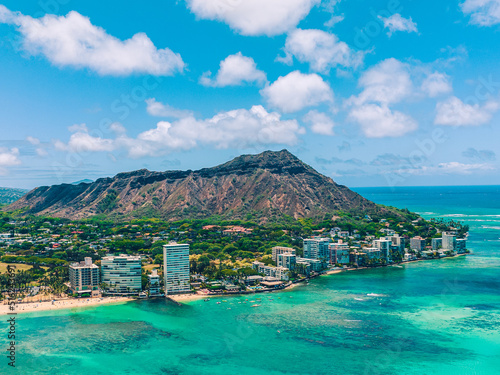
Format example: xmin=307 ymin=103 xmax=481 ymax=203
xmin=5 ymin=150 xmax=387 ymax=220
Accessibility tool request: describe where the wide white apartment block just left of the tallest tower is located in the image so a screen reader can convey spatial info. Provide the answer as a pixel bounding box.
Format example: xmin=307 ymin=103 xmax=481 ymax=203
xmin=101 ymin=254 xmax=142 ymax=294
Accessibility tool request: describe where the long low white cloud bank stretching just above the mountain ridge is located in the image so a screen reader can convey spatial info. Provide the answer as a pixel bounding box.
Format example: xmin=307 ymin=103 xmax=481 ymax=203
xmin=55 ymin=106 xmax=304 ymax=158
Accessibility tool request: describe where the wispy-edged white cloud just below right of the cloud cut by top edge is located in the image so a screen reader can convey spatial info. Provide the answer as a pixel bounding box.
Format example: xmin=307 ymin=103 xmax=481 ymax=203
xmin=277 ymin=29 xmax=364 ymax=73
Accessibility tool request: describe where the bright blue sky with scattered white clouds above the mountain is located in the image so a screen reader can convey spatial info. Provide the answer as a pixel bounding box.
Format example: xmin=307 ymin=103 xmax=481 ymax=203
xmin=0 ymin=0 xmax=500 ymax=188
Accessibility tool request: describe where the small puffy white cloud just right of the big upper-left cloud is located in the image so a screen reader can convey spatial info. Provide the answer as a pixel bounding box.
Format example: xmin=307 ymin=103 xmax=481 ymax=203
xmin=200 ymin=52 xmax=267 ymax=87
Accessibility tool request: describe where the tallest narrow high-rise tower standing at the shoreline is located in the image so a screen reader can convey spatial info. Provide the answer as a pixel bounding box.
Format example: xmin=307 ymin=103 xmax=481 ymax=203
xmin=163 ymin=242 xmax=191 ymax=296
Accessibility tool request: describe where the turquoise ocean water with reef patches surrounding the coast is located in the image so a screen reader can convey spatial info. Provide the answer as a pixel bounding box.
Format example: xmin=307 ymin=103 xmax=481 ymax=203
xmin=0 ymin=187 xmax=500 ymax=375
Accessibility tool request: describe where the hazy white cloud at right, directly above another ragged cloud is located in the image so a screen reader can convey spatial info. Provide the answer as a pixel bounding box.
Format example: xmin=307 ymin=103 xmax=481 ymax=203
xmin=347 ymin=58 xmax=413 ymax=105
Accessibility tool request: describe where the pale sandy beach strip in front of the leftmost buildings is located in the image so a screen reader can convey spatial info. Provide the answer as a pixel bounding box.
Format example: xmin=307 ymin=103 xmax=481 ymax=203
xmin=0 ymin=297 xmax=133 ymax=315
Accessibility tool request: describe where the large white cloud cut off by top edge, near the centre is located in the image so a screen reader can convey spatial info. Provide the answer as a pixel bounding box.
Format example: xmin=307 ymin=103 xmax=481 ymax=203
xmin=187 ymin=0 xmax=321 ymax=36
